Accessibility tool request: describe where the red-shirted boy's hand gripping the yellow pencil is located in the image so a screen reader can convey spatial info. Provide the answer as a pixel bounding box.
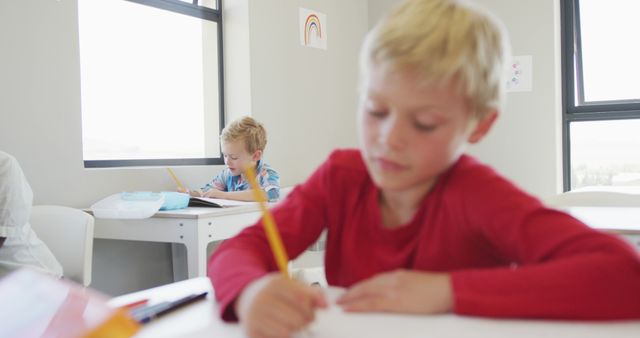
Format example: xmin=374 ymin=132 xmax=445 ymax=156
xmin=235 ymin=273 xmax=327 ymax=338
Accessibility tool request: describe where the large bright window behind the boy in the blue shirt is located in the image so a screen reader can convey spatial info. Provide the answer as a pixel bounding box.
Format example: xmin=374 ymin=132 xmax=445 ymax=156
xmin=78 ymin=0 xmax=224 ymax=167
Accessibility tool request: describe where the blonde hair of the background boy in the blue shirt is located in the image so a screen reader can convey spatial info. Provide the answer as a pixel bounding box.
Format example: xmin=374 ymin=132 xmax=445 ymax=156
xmin=220 ymin=116 xmax=267 ymax=154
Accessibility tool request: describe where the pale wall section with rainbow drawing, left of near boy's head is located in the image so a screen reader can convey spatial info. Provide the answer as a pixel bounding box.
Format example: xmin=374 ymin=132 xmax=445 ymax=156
xmin=250 ymin=0 xmax=367 ymax=183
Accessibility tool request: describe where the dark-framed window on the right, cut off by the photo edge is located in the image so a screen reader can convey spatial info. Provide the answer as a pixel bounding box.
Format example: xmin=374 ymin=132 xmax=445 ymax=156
xmin=561 ymin=0 xmax=640 ymax=191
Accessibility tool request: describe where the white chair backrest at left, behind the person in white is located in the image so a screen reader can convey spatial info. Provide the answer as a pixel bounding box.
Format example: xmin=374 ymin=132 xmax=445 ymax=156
xmin=30 ymin=205 xmax=94 ymax=286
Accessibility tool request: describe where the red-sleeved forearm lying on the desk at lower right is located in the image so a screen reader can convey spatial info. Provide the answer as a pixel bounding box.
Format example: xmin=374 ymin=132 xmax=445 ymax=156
xmin=451 ymin=253 xmax=640 ymax=320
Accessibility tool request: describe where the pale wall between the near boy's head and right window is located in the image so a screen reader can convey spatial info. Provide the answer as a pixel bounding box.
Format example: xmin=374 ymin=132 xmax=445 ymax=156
xmin=369 ymin=0 xmax=562 ymax=197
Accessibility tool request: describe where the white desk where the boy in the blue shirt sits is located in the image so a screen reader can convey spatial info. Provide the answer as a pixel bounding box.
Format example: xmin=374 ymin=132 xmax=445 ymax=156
xmin=94 ymin=205 xmax=261 ymax=278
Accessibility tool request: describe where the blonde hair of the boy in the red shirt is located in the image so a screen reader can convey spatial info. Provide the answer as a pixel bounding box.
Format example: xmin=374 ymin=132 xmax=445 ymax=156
xmin=360 ymin=0 xmax=510 ymax=119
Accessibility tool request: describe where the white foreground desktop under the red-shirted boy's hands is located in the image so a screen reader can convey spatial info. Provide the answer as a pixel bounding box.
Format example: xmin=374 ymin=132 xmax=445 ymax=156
xmin=109 ymin=278 xmax=640 ymax=338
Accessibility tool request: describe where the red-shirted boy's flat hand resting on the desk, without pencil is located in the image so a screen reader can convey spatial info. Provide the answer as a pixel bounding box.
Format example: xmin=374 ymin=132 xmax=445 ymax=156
xmin=337 ymin=270 xmax=453 ymax=314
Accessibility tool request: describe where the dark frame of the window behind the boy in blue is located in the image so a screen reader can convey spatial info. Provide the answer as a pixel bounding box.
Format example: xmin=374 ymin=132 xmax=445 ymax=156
xmin=83 ymin=0 xmax=225 ymax=169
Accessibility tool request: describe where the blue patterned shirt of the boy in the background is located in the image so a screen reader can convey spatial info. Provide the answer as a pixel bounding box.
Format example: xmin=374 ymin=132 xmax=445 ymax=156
xmin=202 ymin=160 xmax=280 ymax=202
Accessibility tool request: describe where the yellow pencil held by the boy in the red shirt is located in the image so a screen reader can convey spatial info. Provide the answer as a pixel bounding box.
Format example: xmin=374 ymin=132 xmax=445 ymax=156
xmin=244 ymin=166 xmax=289 ymax=277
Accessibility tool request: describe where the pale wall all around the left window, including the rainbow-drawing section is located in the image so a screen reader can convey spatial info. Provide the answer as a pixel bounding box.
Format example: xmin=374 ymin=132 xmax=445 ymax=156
xmin=0 ymin=0 xmax=368 ymax=294
